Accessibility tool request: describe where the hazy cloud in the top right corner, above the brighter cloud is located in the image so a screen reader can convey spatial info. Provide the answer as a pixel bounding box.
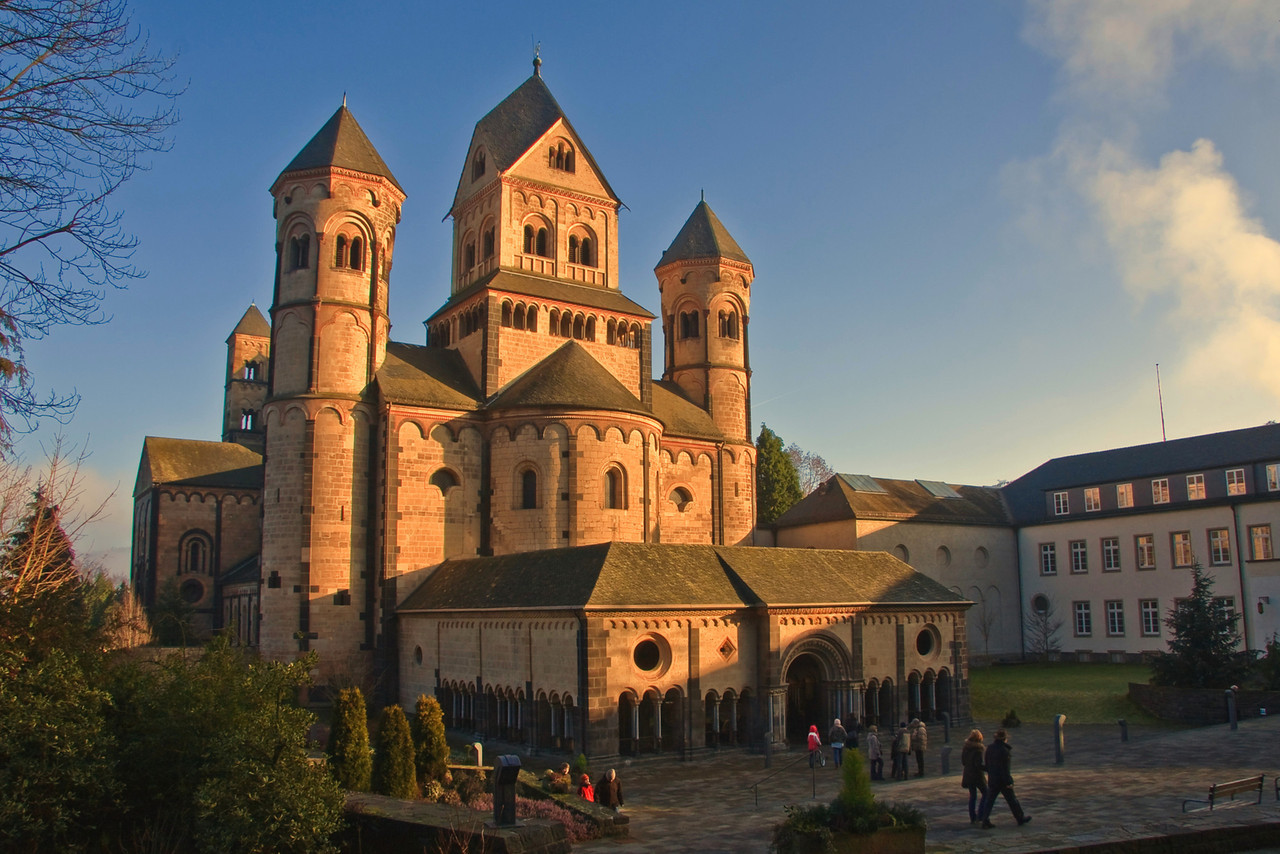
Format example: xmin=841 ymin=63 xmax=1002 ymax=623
xmin=1024 ymin=0 xmax=1280 ymax=100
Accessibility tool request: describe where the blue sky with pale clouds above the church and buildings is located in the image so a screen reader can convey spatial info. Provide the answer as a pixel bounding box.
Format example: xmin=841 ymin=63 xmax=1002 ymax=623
xmin=18 ymin=0 xmax=1280 ymax=576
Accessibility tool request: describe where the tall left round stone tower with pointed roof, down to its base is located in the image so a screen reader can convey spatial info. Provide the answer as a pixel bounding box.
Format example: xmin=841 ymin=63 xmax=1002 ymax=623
xmin=261 ymin=104 xmax=404 ymax=682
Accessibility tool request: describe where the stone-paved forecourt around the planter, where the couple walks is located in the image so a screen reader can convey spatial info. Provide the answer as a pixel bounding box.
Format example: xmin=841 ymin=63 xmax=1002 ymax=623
xmin=573 ymin=716 xmax=1280 ymax=854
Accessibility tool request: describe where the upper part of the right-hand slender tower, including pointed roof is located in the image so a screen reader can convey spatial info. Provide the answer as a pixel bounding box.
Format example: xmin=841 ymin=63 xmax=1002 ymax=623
xmin=654 ymin=200 xmax=755 ymax=444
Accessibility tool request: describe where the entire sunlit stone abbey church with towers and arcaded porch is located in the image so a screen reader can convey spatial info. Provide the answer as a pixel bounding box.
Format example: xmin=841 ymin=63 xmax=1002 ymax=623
xmin=132 ymin=61 xmax=969 ymax=757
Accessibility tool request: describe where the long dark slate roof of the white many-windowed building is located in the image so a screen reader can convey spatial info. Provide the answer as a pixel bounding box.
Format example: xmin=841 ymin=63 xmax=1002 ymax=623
xmin=1004 ymin=424 xmax=1280 ymax=525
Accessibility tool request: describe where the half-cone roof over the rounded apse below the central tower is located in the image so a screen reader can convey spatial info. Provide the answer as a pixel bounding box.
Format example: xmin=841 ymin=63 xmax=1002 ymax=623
xmin=488 ymin=341 xmax=650 ymax=415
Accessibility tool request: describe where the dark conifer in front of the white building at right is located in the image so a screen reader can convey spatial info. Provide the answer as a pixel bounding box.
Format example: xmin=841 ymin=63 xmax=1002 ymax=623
xmin=1152 ymin=561 xmax=1249 ymax=688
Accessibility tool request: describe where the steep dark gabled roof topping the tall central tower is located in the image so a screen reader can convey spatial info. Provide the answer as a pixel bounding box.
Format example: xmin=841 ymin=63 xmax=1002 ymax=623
xmin=449 ymin=73 xmax=618 ymax=213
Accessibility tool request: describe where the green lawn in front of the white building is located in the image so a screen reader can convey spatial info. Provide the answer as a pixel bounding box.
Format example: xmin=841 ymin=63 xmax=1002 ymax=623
xmin=969 ymin=663 xmax=1161 ymax=726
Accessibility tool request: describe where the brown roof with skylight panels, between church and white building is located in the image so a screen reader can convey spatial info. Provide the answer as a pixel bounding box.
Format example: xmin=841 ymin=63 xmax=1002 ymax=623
xmin=774 ymin=475 xmax=1011 ymax=528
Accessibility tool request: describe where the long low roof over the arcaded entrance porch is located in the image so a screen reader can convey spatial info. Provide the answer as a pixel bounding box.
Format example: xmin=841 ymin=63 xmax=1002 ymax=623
xmin=398 ymin=543 xmax=968 ymax=613
